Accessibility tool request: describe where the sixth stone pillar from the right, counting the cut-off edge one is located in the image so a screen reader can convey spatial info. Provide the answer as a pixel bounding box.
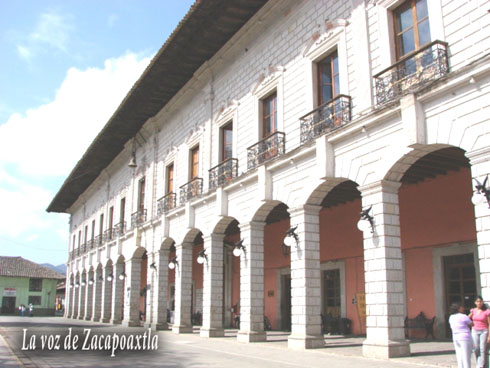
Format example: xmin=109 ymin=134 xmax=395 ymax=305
xmin=172 ymin=243 xmax=193 ymax=333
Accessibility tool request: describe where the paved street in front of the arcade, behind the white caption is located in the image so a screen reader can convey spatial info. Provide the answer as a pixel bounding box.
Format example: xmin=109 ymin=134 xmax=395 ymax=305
xmin=0 ymin=317 xmax=457 ymax=368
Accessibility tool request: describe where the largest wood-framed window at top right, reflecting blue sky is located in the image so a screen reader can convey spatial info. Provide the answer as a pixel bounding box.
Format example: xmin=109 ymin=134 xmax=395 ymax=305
xmin=394 ymin=0 xmax=431 ymax=60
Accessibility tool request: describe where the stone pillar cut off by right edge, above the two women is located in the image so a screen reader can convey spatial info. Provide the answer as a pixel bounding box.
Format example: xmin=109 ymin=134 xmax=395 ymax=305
xmin=466 ymin=148 xmax=490 ymax=303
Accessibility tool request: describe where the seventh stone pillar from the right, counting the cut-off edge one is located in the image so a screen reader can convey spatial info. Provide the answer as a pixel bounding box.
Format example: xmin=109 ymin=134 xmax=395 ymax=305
xmin=145 ymin=249 xmax=169 ymax=330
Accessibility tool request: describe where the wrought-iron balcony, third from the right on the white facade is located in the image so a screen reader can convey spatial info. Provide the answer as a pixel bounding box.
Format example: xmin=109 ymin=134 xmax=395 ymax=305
xmin=247 ymin=132 xmax=286 ymax=170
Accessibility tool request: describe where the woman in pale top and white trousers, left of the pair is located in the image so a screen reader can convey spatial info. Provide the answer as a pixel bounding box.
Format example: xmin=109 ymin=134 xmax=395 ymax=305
xmin=449 ymin=303 xmax=473 ymax=368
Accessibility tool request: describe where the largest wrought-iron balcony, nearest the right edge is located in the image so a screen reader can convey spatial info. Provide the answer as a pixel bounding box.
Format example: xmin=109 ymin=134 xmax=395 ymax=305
xmin=374 ymin=41 xmax=449 ymax=105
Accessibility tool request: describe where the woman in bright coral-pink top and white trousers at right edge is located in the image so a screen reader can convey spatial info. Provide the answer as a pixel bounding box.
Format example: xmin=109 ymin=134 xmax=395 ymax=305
xmin=469 ymin=296 xmax=490 ymax=368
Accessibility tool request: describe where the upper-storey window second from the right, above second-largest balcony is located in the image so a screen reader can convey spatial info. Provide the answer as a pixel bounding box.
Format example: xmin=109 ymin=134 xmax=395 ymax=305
xmin=317 ymin=51 xmax=340 ymax=106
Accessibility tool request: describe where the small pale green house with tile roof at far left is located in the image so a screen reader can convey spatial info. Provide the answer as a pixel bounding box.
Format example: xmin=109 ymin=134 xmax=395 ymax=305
xmin=0 ymin=257 xmax=65 ymax=316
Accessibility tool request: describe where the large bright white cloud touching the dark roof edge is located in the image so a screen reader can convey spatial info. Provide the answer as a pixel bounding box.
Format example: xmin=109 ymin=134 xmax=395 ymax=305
xmin=0 ymin=53 xmax=150 ymax=177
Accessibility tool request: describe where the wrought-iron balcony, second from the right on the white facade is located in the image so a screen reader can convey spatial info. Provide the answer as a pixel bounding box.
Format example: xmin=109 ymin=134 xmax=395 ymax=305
xmin=299 ymin=95 xmax=351 ymax=145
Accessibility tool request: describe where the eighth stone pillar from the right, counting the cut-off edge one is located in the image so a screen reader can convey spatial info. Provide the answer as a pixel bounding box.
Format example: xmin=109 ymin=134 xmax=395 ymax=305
xmin=122 ymin=258 xmax=141 ymax=327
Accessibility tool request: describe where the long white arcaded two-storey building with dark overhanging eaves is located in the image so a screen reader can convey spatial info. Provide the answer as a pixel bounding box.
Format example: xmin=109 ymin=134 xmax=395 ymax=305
xmin=48 ymin=0 xmax=490 ymax=357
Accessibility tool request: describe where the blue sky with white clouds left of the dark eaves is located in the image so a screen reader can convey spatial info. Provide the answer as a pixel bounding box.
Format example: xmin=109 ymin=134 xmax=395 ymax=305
xmin=0 ymin=0 xmax=194 ymax=265
